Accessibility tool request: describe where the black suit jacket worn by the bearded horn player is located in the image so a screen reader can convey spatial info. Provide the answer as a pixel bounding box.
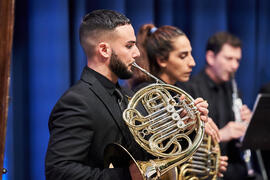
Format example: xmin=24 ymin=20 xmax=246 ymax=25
xmin=45 ymin=67 xmax=147 ymax=180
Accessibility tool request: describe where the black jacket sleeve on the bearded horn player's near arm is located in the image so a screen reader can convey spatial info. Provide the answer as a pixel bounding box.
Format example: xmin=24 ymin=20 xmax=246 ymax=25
xmin=45 ymin=90 xmax=129 ymax=180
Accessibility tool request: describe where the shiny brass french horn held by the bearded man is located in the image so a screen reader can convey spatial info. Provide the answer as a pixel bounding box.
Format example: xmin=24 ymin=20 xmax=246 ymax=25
xmin=105 ymin=63 xmax=204 ymax=180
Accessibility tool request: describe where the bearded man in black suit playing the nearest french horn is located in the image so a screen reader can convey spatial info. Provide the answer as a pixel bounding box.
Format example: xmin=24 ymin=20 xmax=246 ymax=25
xmin=45 ymin=10 xmax=226 ymax=180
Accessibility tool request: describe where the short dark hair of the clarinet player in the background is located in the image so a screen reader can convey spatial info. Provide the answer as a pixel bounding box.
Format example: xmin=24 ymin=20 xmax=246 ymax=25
xmin=206 ymin=32 xmax=242 ymax=54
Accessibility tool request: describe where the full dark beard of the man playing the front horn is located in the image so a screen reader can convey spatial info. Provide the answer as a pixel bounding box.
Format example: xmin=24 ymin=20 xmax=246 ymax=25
xmin=109 ymin=50 xmax=133 ymax=79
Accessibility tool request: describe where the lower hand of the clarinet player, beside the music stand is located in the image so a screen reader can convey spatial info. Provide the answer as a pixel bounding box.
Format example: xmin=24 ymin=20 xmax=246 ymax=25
xmin=219 ymin=121 xmax=247 ymax=142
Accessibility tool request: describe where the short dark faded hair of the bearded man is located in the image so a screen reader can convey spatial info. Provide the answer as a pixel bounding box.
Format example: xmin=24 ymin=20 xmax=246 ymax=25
xmin=79 ymin=9 xmax=131 ymax=56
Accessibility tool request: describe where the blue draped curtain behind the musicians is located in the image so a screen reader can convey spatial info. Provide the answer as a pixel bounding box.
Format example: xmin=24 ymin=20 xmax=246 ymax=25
xmin=3 ymin=0 xmax=270 ymax=180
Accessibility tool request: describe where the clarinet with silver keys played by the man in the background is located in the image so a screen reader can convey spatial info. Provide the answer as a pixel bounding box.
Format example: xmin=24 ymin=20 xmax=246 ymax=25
xmin=232 ymin=77 xmax=255 ymax=177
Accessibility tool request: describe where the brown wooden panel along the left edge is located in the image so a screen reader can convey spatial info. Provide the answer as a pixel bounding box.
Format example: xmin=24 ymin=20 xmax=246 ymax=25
xmin=0 ymin=0 xmax=15 ymax=179
